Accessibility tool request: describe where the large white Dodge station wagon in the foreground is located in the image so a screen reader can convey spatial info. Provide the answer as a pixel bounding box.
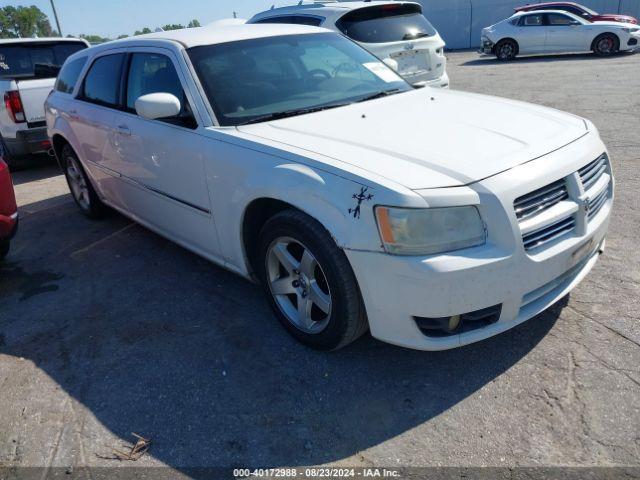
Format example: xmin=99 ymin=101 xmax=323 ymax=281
xmin=46 ymin=25 xmax=613 ymax=350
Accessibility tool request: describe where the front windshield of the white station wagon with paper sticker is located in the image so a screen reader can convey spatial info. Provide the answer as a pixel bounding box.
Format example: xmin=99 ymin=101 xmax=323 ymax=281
xmin=188 ymin=33 xmax=412 ymax=126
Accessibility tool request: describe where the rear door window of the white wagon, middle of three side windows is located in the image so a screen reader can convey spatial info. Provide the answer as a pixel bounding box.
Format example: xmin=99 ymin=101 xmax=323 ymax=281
xmin=82 ymin=53 xmax=124 ymax=107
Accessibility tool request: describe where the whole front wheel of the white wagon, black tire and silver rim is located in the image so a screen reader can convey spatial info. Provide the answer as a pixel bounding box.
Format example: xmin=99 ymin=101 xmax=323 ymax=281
xmin=256 ymin=209 xmax=368 ymax=351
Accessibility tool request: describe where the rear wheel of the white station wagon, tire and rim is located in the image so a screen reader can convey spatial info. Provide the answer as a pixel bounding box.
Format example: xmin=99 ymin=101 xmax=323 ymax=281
xmin=60 ymin=145 xmax=107 ymax=219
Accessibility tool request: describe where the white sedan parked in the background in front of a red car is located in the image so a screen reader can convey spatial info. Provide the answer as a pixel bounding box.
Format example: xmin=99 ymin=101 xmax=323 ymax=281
xmin=480 ymin=10 xmax=640 ymax=60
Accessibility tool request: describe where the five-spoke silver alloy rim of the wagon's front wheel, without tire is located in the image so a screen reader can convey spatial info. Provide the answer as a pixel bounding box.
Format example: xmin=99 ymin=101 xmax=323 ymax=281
xmin=265 ymin=237 xmax=332 ymax=334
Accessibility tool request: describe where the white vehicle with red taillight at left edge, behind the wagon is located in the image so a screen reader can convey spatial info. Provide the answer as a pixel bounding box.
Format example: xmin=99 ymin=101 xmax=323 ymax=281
xmin=0 ymin=38 xmax=89 ymax=168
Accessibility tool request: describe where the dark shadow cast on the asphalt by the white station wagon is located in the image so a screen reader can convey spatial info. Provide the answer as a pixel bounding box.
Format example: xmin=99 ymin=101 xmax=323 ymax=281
xmin=0 ymin=204 xmax=566 ymax=472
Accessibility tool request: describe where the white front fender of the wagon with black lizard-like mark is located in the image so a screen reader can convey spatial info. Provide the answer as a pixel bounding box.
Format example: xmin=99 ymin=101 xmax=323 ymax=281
xmin=205 ymin=144 xmax=416 ymax=274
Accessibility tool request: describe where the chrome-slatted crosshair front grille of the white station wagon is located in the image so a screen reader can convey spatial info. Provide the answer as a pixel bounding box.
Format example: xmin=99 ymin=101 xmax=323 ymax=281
xmin=513 ymin=153 xmax=612 ymax=251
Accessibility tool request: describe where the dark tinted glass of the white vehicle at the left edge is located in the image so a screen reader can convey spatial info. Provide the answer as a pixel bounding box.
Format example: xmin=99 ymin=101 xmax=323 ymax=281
xmin=0 ymin=42 xmax=87 ymax=78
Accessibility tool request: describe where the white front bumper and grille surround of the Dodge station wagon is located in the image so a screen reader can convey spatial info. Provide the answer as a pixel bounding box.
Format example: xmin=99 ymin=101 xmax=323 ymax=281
xmin=346 ymin=134 xmax=613 ymax=350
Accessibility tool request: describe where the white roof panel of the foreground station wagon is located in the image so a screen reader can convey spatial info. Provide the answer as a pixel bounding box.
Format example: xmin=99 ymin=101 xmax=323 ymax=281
xmin=91 ymin=24 xmax=330 ymax=52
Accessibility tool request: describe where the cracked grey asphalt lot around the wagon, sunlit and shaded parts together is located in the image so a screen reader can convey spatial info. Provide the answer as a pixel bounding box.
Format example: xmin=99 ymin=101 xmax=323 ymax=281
xmin=0 ymin=52 xmax=640 ymax=478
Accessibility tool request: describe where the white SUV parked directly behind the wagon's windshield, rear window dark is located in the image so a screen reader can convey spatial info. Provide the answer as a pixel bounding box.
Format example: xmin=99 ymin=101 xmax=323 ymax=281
xmin=249 ymin=1 xmax=449 ymax=88
